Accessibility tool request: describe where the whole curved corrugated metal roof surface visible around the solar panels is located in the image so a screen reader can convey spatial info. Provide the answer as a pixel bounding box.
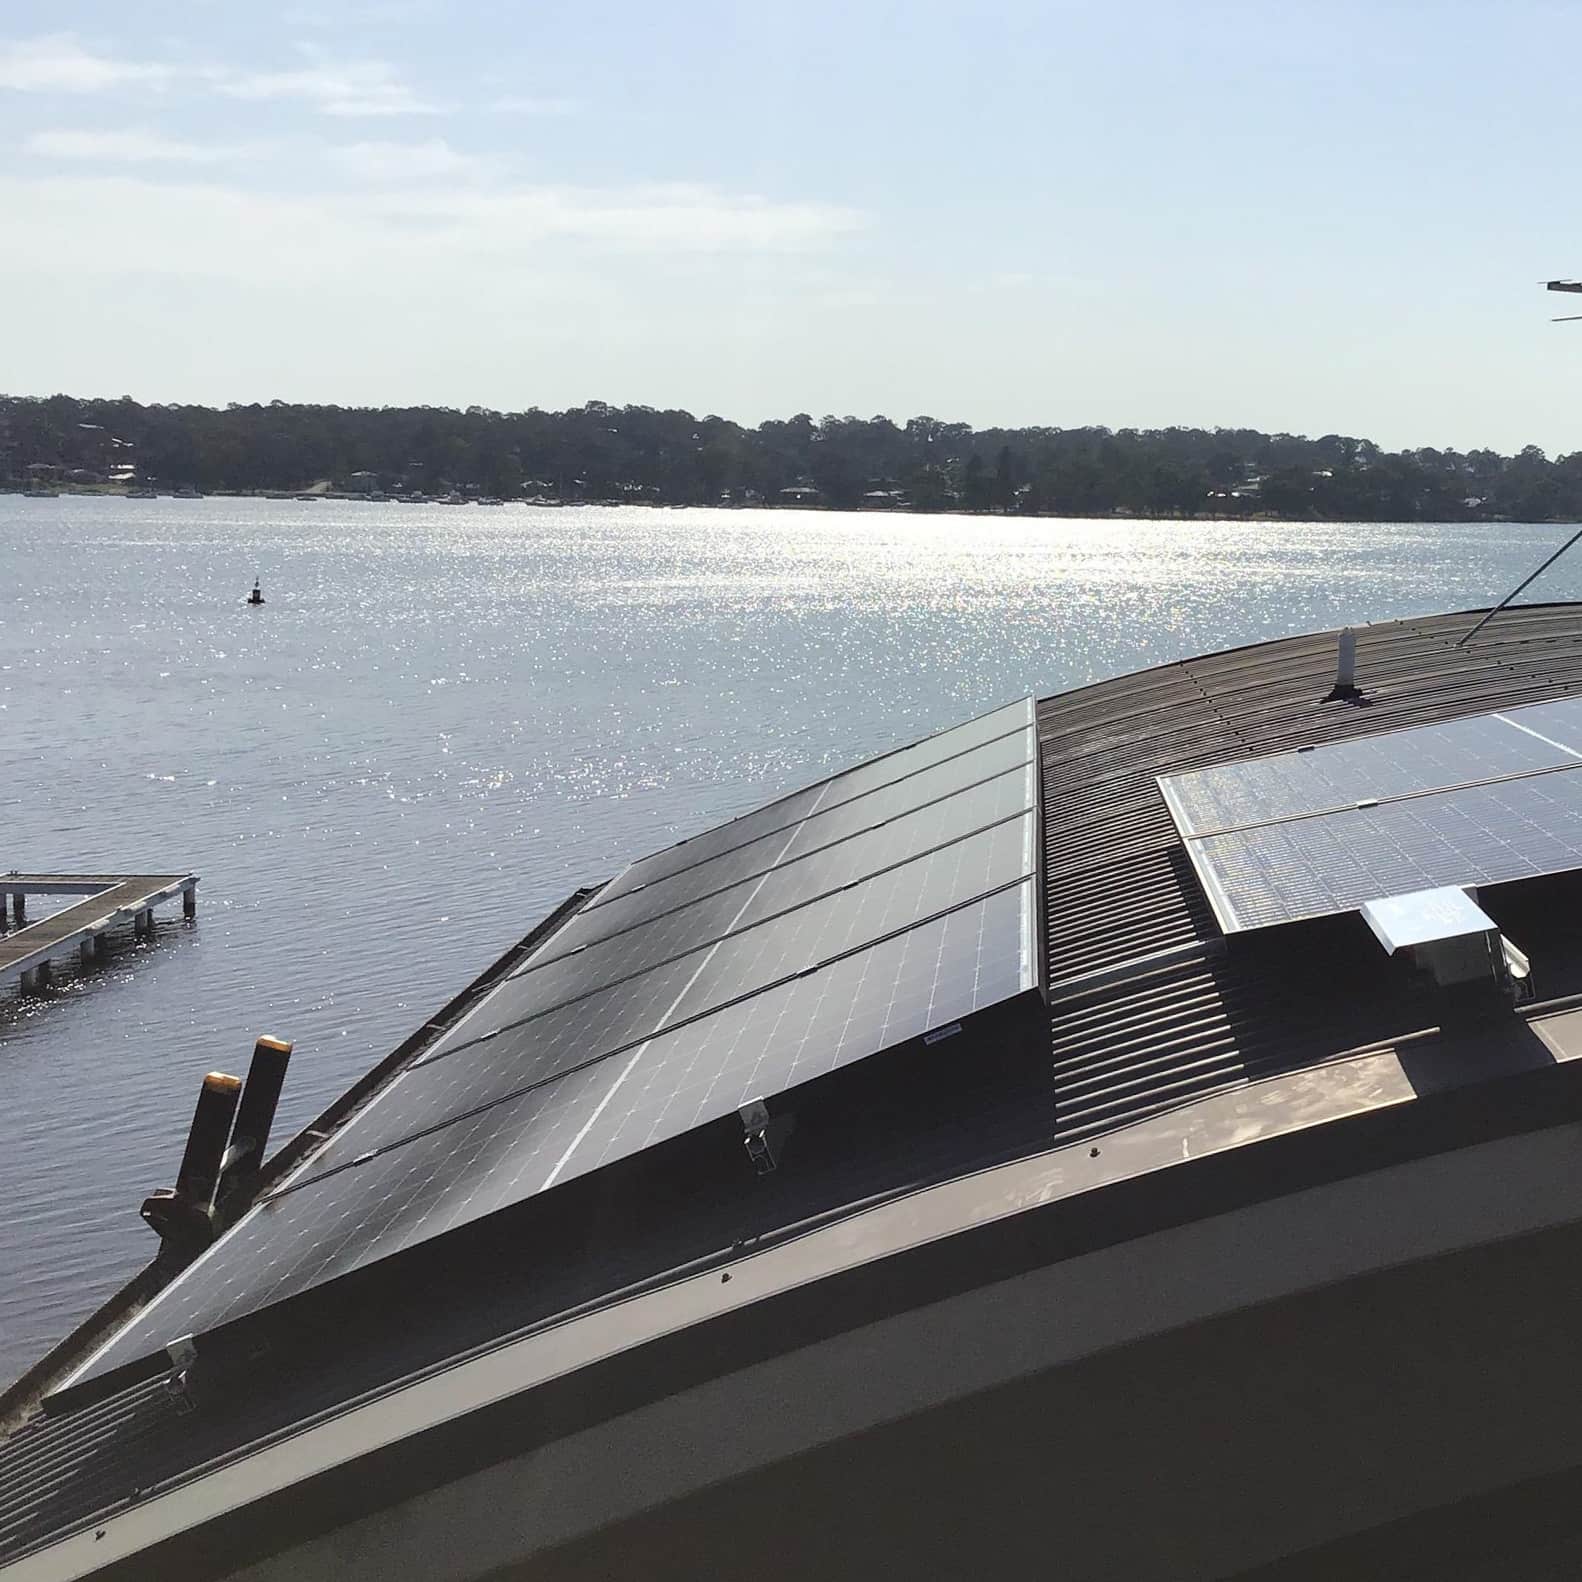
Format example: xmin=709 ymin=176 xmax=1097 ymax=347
xmin=15 ymin=606 xmax=1582 ymax=1563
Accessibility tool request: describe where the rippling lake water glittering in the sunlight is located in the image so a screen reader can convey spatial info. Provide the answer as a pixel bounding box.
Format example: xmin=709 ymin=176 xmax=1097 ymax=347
xmin=0 ymin=497 xmax=1582 ymax=1380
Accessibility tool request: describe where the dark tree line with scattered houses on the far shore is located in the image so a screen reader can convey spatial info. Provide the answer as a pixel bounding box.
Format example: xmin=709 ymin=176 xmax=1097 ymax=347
xmin=0 ymin=396 xmax=1582 ymax=522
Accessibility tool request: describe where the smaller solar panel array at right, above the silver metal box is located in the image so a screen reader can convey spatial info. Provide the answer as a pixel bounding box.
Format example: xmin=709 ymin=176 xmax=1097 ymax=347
xmin=1160 ymin=698 xmax=1582 ymax=933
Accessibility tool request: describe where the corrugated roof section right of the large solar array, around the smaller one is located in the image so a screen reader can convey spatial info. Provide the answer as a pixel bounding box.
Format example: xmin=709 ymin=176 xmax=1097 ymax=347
xmin=1038 ymin=604 xmax=1582 ymax=1136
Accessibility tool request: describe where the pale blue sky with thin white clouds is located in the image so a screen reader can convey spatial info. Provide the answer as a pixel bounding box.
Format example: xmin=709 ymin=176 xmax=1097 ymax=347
xmin=0 ymin=0 xmax=1582 ymax=454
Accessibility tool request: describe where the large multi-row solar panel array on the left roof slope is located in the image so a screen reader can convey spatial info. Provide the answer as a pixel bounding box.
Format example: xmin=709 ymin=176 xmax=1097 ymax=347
xmin=78 ymin=699 xmax=1038 ymax=1381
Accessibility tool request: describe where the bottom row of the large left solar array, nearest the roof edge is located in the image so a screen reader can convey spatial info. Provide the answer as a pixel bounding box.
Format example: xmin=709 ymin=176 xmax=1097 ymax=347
xmin=74 ymin=881 xmax=1036 ymax=1375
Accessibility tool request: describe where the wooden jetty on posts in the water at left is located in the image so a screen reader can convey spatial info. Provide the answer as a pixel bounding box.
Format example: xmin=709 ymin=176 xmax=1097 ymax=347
xmin=0 ymin=873 xmax=198 ymax=993
